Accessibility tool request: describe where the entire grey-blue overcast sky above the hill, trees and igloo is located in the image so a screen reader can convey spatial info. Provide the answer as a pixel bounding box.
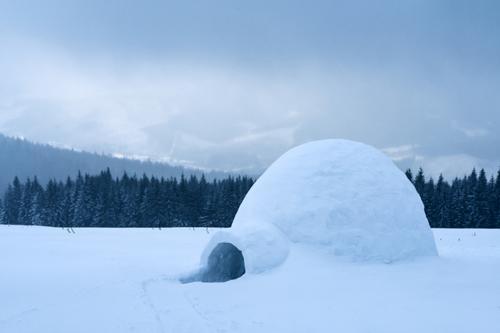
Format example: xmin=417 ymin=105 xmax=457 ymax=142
xmin=0 ymin=0 xmax=500 ymax=176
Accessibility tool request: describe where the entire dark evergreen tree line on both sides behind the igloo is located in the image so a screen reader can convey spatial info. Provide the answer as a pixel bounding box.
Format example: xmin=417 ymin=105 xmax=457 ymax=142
xmin=0 ymin=169 xmax=500 ymax=228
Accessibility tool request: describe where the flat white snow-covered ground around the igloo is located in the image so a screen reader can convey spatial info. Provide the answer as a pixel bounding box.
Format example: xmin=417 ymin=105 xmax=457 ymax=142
xmin=0 ymin=226 xmax=500 ymax=333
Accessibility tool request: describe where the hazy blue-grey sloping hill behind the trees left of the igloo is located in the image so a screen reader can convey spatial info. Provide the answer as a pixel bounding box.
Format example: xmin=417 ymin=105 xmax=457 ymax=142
xmin=0 ymin=134 xmax=229 ymax=193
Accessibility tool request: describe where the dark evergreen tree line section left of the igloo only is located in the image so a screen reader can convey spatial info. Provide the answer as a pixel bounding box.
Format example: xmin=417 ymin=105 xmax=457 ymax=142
xmin=0 ymin=169 xmax=253 ymax=228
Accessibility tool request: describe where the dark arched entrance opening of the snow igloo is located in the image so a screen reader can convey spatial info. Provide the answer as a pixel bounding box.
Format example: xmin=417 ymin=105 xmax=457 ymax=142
xmin=181 ymin=243 xmax=245 ymax=283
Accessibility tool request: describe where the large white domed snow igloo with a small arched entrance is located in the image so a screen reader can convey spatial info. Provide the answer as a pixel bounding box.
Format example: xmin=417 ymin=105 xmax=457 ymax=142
xmin=193 ymin=140 xmax=437 ymax=280
